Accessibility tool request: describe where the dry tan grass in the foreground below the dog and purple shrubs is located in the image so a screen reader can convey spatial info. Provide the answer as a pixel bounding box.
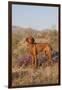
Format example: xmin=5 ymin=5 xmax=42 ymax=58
xmin=12 ymin=63 xmax=59 ymax=86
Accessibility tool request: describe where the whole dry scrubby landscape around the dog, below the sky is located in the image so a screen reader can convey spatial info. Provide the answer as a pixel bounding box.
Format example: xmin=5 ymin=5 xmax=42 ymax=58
xmin=12 ymin=27 xmax=59 ymax=86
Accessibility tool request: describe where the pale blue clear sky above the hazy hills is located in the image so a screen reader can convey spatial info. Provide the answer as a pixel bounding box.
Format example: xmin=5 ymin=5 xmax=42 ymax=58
xmin=12 ymin=4 xmax=58 ymax=30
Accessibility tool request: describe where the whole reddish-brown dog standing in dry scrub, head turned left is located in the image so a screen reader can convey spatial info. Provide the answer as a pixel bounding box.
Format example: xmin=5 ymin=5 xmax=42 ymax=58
xmin=26 ymin=36 xmax=52 ymax=67
